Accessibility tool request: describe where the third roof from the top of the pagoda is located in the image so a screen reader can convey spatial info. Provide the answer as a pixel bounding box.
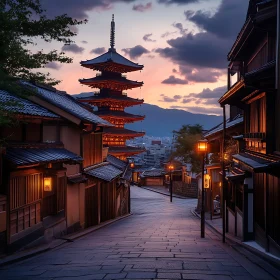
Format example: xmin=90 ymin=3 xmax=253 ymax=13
xmin=77 ymin=94 xmax=144 ymax=106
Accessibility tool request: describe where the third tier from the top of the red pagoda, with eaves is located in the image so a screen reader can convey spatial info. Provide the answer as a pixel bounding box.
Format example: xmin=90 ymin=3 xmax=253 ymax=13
xmin=79 ymin=93 xmax=144 ymax=109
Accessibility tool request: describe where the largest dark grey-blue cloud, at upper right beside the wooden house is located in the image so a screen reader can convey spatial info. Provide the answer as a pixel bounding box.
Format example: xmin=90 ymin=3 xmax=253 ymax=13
xmin=155 ymin=0 xmax=248 ymax=75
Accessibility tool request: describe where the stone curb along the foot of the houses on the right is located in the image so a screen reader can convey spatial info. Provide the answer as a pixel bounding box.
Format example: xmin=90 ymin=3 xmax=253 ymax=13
xmin=191 ymin=210 xmax=280 ymax=269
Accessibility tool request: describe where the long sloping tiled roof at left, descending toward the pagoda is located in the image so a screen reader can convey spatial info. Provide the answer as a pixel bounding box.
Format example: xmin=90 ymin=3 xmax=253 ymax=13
xmin=22 ymin=82 xmax=112 ymax=126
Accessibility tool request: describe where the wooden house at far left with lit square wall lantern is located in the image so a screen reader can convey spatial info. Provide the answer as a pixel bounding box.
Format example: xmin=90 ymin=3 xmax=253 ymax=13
xmin=0 ymin=91 xmax=82 ymax=250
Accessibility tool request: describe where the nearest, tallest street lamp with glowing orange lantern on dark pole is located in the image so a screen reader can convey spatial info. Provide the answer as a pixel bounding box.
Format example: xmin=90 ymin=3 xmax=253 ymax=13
xmin=197 ymin=140 xmax=208 ymax=238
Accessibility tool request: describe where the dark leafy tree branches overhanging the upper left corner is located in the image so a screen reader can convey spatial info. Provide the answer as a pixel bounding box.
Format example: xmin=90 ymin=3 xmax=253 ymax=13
xmin=0 ymin=0 xmax=86 ymax=123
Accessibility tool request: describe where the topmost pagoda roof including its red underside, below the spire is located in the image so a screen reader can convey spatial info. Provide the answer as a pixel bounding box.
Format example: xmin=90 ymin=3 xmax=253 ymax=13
xmin=80 ymin=48 xmax=144 ymax=73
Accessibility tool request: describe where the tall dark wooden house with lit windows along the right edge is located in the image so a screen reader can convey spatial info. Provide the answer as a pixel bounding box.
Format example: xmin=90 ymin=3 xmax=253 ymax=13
xmin=219 ymin=0 xmax=280 ymax=255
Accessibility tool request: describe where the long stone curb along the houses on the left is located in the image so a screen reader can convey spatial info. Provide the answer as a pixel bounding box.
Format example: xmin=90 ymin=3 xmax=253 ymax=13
xmin=0 ymin=213 xmax=133 ymax=267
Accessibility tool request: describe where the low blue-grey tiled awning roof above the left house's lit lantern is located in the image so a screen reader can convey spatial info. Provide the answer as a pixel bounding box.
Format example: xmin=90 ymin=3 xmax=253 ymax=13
xmin=5 ymin=147 xmax=83 ymax=166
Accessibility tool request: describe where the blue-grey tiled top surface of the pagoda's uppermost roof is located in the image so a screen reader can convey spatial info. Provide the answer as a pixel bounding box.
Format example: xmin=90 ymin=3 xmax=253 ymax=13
xmin=81 ymin=50 xmax=143 ymax=70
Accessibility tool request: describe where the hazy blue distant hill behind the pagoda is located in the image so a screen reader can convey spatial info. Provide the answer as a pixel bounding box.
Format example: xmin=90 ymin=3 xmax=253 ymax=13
xmin=73 ymin=93 xmax=222 ymax=137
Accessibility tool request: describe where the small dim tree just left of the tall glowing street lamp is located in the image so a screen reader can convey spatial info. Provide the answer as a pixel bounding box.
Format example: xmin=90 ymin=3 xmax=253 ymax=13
xmin=172 ymin=124 xmax=202 ymax=173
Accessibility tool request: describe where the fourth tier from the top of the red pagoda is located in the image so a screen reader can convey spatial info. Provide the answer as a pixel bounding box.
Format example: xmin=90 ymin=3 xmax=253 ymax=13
xmin=95 ymin=110 xmax=145 ymax=124
